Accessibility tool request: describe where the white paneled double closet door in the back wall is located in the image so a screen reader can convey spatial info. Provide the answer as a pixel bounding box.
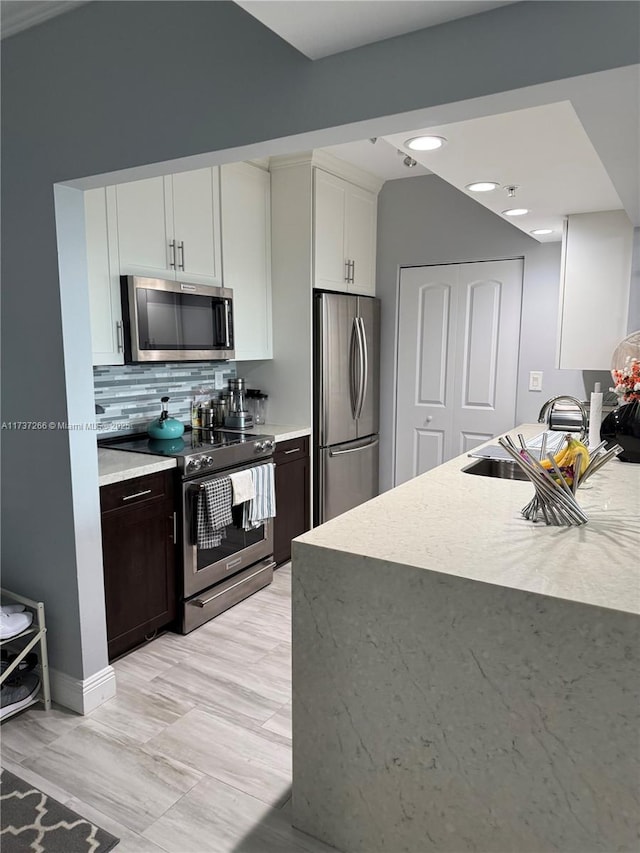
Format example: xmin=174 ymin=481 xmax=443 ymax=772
xmin=395 ymin=260 xmax=522 ymax=485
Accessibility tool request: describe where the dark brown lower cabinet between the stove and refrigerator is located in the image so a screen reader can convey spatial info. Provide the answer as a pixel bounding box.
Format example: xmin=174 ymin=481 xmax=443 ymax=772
xmin=273 ymin=436 xmax=310 ymax=565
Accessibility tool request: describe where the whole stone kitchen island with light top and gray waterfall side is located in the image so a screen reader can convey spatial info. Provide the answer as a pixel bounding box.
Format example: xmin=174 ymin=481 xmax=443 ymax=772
xmin=293 ymin=424 xmax=640 ymax=853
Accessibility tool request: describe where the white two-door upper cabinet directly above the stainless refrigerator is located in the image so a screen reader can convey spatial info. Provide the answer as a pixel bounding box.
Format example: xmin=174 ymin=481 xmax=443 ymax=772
xmin=313 ymin=168 xmax=377 ymax=296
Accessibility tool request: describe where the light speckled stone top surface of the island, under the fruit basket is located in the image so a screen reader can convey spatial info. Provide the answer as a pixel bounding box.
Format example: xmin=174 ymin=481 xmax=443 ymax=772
xmin=294 ymin=424 xmax=640 ymax=613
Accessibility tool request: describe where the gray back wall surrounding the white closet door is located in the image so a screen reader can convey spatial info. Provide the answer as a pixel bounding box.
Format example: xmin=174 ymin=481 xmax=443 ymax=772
xmin=377 ymin=175 xmax=611 ymax=491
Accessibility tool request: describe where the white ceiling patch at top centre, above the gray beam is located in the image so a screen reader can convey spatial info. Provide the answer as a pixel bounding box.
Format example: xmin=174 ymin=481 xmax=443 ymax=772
xmin=236 ymin=0 xmax=513 ymax=59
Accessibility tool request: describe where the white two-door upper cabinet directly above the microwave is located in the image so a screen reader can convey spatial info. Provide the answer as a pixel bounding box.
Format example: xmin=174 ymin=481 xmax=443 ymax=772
xmin=115 ymin=167 xmax=222 ymax=285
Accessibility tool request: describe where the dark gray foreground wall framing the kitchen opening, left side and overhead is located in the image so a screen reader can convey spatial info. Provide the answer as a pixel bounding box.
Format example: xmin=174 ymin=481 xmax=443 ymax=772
xmin=2 ymin=0 xmax=638 ymax=678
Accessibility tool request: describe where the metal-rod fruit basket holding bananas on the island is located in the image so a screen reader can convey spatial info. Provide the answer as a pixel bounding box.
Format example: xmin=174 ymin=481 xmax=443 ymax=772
xmin=498 ymin=434 xmax=622 ymax=526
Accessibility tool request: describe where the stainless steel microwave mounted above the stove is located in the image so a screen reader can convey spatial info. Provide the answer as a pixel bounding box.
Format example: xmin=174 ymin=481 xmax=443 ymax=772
xmin=120 ymin=275 xmax=235 ymax=364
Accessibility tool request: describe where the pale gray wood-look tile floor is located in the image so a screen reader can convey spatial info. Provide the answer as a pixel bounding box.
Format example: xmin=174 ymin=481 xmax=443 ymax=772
xmin=1 ymin=565 xmax=332 ymax=853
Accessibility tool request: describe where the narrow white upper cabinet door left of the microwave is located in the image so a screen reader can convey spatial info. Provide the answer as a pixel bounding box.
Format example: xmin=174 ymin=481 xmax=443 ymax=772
xmin=84 ymin=187 xmax=124 ymax=364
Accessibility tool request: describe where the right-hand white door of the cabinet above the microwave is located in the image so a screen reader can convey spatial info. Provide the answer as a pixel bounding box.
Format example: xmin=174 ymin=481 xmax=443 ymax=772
xmin=171 ymin=166 xmax=222 ymax=285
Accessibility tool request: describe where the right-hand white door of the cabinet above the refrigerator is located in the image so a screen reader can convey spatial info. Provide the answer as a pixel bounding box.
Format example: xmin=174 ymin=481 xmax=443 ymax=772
xmin=345 ymin=185 xmax=378 ymax=296
